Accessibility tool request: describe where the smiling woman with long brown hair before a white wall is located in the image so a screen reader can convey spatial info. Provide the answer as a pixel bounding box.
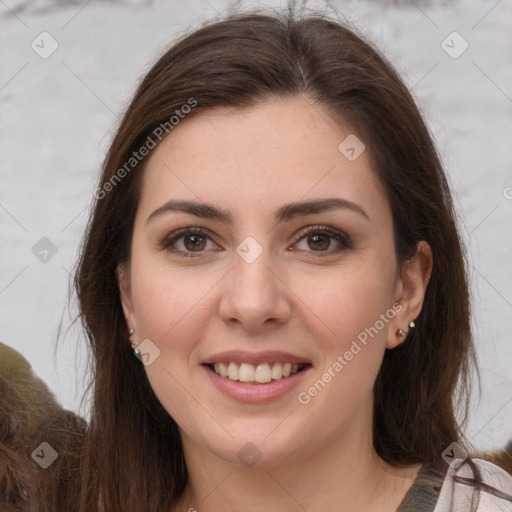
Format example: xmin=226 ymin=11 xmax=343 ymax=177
xmin=4 ymin=5 xmax=512 ymax=512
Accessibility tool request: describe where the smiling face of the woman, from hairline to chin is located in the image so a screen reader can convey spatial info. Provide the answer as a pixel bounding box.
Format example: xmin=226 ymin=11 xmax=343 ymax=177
xmin=120 ymin=98 xmax=423 ymax=465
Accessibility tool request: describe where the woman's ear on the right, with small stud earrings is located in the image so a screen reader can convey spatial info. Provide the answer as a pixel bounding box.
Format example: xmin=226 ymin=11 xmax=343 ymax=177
xmin=386 ymin=240 xmax=433 ymax=349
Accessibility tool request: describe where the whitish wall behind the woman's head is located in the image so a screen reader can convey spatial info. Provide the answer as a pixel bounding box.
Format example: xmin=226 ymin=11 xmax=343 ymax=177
xmin=0 ymin=0 xmax=512 ymax=448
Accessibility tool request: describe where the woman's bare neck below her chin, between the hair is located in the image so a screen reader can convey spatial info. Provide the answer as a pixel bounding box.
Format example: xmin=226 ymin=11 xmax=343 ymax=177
xmin=174 ymin=402 xmax=421 ymax=512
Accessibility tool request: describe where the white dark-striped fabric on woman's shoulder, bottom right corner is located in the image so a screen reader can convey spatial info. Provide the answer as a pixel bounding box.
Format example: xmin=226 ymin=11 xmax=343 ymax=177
xmin=434 ymin=459 xmax=512 ymax=512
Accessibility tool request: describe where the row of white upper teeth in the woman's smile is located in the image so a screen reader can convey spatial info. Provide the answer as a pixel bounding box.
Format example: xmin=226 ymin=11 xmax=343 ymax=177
xmin=213 ymin=361 xmax=304 ymax=384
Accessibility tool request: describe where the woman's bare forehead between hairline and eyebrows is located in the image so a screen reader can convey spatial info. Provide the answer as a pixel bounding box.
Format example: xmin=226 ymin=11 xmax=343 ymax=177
xmin=139 ymin=97 xmax=386 ymax=224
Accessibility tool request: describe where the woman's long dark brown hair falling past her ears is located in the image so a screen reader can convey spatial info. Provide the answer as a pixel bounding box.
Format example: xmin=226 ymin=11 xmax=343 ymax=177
xmin=69 ymin=5 xmax=476 ymax=512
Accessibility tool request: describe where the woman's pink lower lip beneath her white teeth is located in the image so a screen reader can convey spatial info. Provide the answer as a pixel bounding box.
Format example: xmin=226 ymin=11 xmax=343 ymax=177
xmin=203 ymin=365 xmax=311 ymax=403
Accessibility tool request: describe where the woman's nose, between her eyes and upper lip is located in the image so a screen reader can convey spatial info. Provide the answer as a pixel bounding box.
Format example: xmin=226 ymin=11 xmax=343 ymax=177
xmin=219 ymin=244 xmax=293 ymax=332
